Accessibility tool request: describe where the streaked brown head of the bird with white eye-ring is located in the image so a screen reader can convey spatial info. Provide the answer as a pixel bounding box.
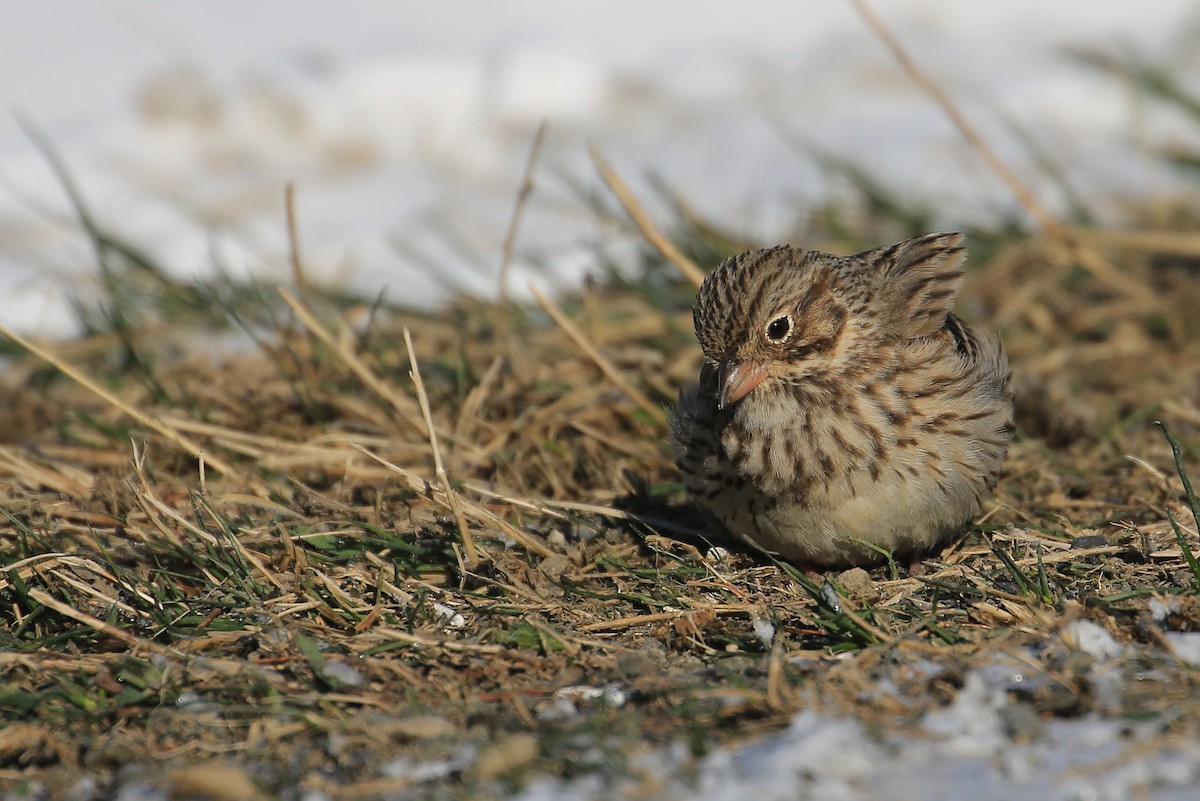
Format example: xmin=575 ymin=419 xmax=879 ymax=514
xmin=692 ymin=234 xmax=964 ymax=409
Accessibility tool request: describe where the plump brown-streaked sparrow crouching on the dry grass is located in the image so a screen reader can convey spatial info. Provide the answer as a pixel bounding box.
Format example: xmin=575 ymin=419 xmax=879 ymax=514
xmin=668 ymin=234 xmax=1013 ymax=572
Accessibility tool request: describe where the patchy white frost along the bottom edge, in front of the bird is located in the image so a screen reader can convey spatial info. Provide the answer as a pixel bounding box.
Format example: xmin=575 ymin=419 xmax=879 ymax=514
xmin=515 ymin=662 xmax=1200 ymax=801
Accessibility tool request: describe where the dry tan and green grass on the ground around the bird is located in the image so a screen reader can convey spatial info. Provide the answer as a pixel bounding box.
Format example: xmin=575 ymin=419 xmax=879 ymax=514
xmin=7 ymin=34 xmax=1200 ymax=799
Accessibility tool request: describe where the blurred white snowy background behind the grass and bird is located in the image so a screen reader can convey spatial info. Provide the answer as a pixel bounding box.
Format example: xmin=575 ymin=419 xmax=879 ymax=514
xmin=0 ymin=0 xmax=1200 ymax=336
